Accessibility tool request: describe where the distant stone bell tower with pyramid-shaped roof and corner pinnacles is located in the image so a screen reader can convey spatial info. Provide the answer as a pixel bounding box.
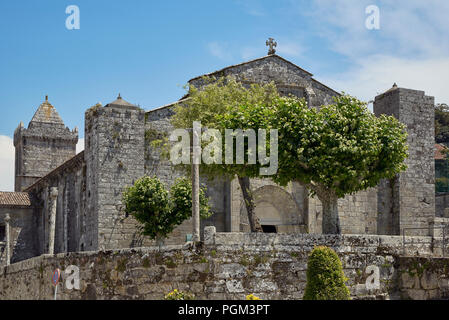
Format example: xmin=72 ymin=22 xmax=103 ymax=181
xmin=14 ymin=97 xmax=78 ymax=192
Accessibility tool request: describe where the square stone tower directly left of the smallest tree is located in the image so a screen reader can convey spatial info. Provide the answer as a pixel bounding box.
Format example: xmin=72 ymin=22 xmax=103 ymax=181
xmin=84 ymin=95 xmax=145 ymax=250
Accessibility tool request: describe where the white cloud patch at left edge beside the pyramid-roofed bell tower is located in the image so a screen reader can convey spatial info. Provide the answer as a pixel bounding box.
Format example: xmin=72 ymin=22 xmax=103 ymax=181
xmin=0 ymin=136 xmax=15 ymax=191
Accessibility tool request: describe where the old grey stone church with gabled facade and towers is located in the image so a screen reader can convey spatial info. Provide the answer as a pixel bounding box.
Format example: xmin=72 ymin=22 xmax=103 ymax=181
xmin=0 ymin=44 xmax=449 ymax=265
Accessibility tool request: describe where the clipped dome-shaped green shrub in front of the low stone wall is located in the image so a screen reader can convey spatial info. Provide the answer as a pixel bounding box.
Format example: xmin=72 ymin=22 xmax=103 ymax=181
xmin=303 ymin=246 xmax=350 ymax=300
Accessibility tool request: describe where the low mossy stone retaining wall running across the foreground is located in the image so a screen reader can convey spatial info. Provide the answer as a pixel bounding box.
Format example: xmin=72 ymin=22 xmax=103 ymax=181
xmin=0 ymin=229 xmax=449 ymax=299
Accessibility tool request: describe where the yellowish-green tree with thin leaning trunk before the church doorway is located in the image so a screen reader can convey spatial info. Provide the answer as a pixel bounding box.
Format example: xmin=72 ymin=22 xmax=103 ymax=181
xmin=171 ymin=77 xmax=279 ymax=232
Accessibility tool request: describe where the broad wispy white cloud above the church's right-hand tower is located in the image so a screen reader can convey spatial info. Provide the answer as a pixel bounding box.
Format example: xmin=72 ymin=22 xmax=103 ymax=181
xmin=308 ymin=0 xmax=449 ymax=103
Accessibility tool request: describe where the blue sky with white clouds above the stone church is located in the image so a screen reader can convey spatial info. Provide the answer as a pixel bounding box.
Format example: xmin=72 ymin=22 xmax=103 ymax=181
xmin=0 ymin=0 xmax=449 ymax=190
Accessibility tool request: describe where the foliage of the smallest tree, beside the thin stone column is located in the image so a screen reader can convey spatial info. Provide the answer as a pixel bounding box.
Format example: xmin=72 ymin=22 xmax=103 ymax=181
xmin=123 ymin=176 xmax=211 ymax=239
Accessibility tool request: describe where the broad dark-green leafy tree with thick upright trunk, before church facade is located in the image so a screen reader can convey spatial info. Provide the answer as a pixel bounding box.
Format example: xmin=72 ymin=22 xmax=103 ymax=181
xmin=266 ymin=95 xmax=407 ymax=234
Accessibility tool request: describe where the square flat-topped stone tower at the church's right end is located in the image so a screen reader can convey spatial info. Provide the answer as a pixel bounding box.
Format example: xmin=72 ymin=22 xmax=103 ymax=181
xmin=374 ymin=84 xmax=435 ymax=236
